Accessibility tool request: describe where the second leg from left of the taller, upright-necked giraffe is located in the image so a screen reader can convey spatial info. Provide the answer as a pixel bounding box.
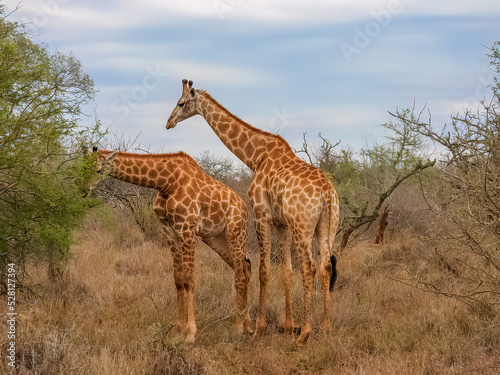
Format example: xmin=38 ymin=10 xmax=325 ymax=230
xmin=276 ymin=226 xmax=295 ymax=333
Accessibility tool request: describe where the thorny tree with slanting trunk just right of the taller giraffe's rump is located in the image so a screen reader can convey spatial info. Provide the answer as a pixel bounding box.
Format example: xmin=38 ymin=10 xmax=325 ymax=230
xmin=298 ymin=122 xmax=434 ymax=251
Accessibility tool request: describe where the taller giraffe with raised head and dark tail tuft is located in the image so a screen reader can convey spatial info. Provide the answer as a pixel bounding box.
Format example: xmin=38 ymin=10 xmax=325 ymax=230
xmin=166 ymin=80 xmax=339 ymax=345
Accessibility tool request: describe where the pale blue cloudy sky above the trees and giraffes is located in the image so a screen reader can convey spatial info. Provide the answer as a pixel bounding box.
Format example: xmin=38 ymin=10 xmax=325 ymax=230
xmin=0 ymin=0 xmax=500 ymax=163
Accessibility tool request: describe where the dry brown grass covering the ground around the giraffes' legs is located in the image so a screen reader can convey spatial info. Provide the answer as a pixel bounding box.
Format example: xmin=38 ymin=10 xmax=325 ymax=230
xmin=0 ymin=210 xmax=500 ymax=374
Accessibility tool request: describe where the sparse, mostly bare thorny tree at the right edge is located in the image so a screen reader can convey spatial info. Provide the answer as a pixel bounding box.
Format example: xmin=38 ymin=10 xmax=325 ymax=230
xmin=393 ymin=42 xmax=500 ymax=311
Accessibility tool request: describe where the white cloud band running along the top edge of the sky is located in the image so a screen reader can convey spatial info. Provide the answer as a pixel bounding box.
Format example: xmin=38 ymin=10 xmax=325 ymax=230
xmin=6 ymin=0 xmax=500 ymax=39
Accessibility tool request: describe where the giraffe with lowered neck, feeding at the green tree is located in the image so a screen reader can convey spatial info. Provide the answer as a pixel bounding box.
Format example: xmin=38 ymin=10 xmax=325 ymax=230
xmin=94 ymin=148 xmax=252 ymax=343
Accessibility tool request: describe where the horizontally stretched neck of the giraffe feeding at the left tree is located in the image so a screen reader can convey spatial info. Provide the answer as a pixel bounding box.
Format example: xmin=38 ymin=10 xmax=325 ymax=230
xmin=111 ymin=153 xmax=178 ymax=191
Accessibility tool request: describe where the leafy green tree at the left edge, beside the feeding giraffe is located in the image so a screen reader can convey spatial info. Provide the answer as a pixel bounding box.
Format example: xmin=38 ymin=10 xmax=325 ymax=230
xmin=0 ymin=7 xmax=99 ymax=292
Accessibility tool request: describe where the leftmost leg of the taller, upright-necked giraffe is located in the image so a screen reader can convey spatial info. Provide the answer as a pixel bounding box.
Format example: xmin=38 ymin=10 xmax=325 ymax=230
xmin=254 ymin=214 xmax=271 ymax=338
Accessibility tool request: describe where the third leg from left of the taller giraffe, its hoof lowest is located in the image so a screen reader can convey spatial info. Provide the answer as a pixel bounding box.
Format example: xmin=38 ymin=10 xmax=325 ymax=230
xmin=295 ymin=235 xmax=316 ymax=346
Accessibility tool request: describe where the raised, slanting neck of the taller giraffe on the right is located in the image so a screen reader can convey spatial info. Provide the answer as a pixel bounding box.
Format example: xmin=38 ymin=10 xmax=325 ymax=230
xmin=199 ymin=91 xmax=293 ymax=172
